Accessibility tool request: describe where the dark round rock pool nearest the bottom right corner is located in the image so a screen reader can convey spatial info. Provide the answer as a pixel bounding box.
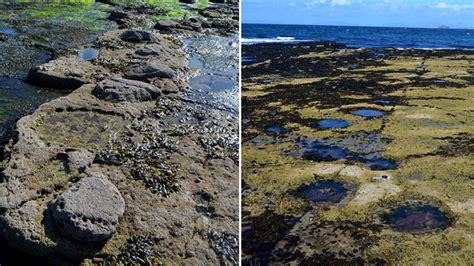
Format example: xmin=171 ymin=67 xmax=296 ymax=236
xmin=381 ymin=204 xmax=450 ymax=233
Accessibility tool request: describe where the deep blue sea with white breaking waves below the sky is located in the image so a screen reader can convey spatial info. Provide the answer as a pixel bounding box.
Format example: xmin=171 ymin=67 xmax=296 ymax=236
xmin=242 ymin=24 xmax=474 ymax=49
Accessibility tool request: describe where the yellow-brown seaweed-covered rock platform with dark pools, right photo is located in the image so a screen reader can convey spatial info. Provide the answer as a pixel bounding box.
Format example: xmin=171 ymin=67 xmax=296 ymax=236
xmin=242 ymin=42 xmax=474 ymax=265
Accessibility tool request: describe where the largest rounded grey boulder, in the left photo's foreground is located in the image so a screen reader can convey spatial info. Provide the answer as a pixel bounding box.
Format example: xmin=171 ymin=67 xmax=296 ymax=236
xmin=51 ymin=176 xmax=125 ymax=242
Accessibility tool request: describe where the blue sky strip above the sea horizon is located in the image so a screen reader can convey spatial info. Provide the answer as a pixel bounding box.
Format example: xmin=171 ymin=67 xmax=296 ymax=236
xmin=241 ymin=0 xmax=474 ymax=29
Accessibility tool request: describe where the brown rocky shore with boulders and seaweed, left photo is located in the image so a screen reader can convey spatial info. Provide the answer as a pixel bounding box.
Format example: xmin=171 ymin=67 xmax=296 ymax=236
xmin=0 ymin=4 xmax=239 ymax=264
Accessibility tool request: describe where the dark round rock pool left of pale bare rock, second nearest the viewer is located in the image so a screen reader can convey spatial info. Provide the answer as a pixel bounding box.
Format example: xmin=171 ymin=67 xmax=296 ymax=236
xmin=296 ymin=180 xmax=349 ymax=203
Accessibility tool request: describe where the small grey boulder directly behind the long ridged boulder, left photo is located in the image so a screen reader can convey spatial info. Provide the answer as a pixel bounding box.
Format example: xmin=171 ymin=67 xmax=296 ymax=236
xmin=124 ymin=60 xmax=176 ymax=80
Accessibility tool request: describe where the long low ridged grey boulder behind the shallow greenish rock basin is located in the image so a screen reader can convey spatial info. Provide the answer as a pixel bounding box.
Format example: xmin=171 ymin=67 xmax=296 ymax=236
xmin=92 ymin=78 xmax=161 ymax=102
